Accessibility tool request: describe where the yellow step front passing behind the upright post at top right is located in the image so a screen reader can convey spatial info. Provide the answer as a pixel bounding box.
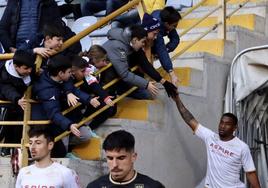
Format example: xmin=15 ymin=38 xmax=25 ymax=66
xmin=178 ymin=14 xmax=256 ymax=30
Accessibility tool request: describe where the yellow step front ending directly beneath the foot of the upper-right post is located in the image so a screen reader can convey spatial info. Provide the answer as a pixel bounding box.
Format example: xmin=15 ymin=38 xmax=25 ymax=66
xmin=174 ymin=39 xmax=224 ymax=56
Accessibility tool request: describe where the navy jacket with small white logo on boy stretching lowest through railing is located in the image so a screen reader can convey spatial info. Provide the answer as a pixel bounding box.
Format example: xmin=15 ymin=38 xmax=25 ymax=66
xmin=33 ymin=71 xmax=91 ymax=131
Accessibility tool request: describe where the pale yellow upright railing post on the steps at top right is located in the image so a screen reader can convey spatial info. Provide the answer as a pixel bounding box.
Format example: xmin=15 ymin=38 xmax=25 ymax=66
xmin=218 ymin=0 xmax=226 ymax=40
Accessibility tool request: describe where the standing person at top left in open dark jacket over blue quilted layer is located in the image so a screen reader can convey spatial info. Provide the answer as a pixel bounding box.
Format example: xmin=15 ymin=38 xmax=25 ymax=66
xmin=0 ymin=0 xmax=61 ymax=52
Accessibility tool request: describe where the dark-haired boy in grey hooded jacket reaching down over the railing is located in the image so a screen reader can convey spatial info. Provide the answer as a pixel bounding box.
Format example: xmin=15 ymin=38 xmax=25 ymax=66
xmin=103 ymin=25 xmax=177 ymax=99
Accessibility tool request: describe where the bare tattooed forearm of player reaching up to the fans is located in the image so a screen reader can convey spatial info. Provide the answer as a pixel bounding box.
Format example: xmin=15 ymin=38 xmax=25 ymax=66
xmin=173 ymin=94 xmax=198 ymax=131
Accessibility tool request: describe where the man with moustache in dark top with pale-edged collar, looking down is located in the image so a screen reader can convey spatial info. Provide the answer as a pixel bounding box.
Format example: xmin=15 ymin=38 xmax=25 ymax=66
xmin=87 ymin=130 xmax=165 ymax=188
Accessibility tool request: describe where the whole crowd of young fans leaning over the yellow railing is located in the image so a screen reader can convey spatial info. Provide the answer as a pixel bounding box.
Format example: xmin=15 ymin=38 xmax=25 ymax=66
xmin=0 ymin=0 xmax=181 ymax=157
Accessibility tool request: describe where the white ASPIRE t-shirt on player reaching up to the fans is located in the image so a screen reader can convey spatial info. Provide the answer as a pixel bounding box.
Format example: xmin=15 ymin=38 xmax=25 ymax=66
xmin=195 ymin=124 xmax=255 ymax=188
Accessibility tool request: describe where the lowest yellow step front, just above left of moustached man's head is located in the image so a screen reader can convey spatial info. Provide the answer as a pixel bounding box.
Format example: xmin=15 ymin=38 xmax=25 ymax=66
xmin=72 ymin=138 xmax=102 ymax=160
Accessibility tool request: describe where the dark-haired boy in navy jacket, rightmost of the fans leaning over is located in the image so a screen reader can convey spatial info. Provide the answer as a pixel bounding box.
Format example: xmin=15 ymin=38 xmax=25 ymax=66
xmin=147 ymin=7 xmax=181 ymax=85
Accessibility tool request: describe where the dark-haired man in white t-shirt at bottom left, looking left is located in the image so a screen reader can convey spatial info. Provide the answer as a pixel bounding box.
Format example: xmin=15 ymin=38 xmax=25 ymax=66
xmin=16 ymin=126 xmax=80 ymax=188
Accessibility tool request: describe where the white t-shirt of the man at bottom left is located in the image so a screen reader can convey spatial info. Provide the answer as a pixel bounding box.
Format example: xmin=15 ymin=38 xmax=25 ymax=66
xmin=16 ymin=162 xmax=80 ymax=188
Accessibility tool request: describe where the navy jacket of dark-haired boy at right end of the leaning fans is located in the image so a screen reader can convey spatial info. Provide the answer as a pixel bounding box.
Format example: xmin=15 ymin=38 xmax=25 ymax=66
xmin=152 ymin=10 xmax=180 ymax=72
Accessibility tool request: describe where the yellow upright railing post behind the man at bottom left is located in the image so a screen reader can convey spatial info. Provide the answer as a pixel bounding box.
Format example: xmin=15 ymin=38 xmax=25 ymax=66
xmin=21 ymin=86 xmax=32 ymax=167
